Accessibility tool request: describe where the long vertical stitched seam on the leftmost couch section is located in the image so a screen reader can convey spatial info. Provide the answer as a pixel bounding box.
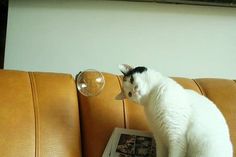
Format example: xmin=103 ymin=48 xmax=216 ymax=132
xmin=28 ymin=72 xmax=40 ymax=157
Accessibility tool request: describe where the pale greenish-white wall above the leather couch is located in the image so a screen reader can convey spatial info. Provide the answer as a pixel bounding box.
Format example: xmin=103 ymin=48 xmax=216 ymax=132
xmin=5 ymin=0 xmax=236 ymax=79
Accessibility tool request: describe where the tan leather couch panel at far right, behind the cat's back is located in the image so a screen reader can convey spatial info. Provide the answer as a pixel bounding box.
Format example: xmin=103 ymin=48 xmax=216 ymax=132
xmin=196 ymin=79 xmax=236 ymax=156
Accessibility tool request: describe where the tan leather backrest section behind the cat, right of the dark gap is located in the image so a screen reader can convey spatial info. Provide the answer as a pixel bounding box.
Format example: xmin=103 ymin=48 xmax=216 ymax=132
xmin=79 ymin=73 xmax=236 ymax=157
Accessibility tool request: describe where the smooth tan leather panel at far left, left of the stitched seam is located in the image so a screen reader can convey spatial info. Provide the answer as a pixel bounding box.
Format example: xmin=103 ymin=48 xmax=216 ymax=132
xmin=0 ymin=71 xmax=35 ymax=157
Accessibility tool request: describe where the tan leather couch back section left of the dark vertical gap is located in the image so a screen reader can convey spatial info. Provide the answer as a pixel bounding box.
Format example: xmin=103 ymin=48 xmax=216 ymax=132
xmin=0 ymin=70 xmax=82 ymax=157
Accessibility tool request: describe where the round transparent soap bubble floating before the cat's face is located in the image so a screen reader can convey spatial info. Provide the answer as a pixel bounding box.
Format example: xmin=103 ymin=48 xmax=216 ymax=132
xmin=77 ymin=69 xmax=105 ymax=96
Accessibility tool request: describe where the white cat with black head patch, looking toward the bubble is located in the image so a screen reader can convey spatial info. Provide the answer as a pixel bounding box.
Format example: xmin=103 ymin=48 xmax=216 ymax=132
xmin=117 ymin=65 xmax=233 ymax=157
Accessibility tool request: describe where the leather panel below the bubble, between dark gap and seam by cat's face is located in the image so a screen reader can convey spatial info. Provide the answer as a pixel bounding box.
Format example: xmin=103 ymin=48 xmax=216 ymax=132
xmin=79 ymin=73 xmax=125 ymax=157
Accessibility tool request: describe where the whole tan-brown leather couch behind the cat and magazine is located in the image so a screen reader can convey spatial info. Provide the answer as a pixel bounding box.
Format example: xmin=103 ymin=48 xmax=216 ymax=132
xmin=0 ymin=70 xmax=236 ymax=157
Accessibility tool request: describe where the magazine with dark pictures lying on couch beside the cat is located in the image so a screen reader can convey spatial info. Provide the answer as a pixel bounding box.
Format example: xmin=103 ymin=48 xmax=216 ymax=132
xmin=102 ymin=128 xmax=156 ymax=157
